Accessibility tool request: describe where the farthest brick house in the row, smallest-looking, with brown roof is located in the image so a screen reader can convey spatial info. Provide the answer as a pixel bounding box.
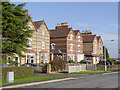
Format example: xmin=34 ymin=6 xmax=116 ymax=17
xmin=82 ymin=30 xmax=103 ymax=64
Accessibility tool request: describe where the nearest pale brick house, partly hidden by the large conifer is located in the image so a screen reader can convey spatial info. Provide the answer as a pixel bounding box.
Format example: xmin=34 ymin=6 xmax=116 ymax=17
xmin=7 ymin=20 xmax=50 ymax=65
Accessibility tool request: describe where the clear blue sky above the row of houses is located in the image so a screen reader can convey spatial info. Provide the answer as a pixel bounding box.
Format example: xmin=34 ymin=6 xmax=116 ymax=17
xmin=12 ymin=2 xmax=118 ymax=58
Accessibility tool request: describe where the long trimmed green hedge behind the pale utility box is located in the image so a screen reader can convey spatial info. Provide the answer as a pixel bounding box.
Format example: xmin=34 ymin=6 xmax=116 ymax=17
xmin=2 ymin=66 xmax=34 ymax=79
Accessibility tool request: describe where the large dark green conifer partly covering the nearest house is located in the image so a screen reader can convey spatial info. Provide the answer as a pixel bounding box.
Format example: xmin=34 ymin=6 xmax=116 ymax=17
xmin=2 ymin=2 xmax=33 ymax=56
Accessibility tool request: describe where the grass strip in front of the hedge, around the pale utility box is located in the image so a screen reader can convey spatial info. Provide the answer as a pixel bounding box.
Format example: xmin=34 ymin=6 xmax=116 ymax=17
xmin=2 ymin=76 xmax=64 ymax=85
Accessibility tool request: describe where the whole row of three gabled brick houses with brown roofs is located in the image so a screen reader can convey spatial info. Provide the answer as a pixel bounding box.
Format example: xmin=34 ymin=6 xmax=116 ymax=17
xmin=7 ymin=14 xmax=103 ymax=65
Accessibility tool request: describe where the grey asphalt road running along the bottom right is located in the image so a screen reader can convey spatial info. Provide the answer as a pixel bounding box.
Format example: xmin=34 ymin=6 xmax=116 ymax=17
xmin=23 ymin=74 xmax=118 ymax=88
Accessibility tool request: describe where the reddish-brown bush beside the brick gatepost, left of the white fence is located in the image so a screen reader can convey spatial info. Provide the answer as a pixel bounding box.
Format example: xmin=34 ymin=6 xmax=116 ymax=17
xmin=49 ymin=57 xmax=66 ymax=71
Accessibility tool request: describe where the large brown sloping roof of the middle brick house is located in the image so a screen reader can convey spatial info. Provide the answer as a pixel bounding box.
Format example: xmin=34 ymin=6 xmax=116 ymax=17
xmin=50 ymin=28 xmax=71 ymax=38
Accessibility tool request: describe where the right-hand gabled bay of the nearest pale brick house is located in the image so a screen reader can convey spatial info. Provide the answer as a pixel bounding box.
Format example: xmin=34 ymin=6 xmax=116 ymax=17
xmin=34 ymin=20 xmax=50 ymax=64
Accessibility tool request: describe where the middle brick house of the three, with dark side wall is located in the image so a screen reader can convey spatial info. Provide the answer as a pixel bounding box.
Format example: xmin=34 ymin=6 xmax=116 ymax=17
xmin=50 ymin=23 xmax=82 ymax=62
